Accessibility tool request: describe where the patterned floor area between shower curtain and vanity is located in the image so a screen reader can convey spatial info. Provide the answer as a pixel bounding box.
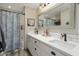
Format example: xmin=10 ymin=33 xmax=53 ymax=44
xmin=1 ymin=50 xmax=32 ymax=56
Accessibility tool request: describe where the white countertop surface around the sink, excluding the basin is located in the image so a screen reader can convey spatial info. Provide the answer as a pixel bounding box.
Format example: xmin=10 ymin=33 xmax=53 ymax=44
xmin=27 ymin=33 xmax=79 ymax=56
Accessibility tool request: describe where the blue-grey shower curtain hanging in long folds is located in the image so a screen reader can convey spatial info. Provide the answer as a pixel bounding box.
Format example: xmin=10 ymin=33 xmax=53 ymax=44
xmin=0 ymin=11 xmax=21 ymax=51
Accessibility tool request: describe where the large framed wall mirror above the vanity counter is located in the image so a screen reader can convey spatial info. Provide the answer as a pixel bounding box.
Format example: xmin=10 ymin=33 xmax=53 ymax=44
xmin=38 ymin=3 xmax=75 ymax=28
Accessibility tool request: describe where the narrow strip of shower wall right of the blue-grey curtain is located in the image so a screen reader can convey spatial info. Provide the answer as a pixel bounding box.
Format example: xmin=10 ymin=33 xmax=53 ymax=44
xmin=20 ymin=14 xmax=25 ymax=49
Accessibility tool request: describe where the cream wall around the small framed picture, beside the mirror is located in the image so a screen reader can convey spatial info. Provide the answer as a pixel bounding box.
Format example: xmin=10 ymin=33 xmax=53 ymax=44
xmin=25 ymin=7 xmax=37 ymax=49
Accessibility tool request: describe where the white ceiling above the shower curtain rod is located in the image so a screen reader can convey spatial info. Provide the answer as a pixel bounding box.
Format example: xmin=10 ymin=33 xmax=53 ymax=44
xmin=0 ymin=3 xmax=40 ymax=12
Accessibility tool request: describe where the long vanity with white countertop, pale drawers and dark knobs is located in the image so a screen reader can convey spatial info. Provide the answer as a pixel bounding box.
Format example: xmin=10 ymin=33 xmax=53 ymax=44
xmin=27 ymin=33 xmax=79 ymax=56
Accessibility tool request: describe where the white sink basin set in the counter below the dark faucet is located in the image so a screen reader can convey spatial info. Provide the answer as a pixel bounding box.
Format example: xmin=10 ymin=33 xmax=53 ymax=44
xmin=49 ymin=40 xmax=76 ymax=49
